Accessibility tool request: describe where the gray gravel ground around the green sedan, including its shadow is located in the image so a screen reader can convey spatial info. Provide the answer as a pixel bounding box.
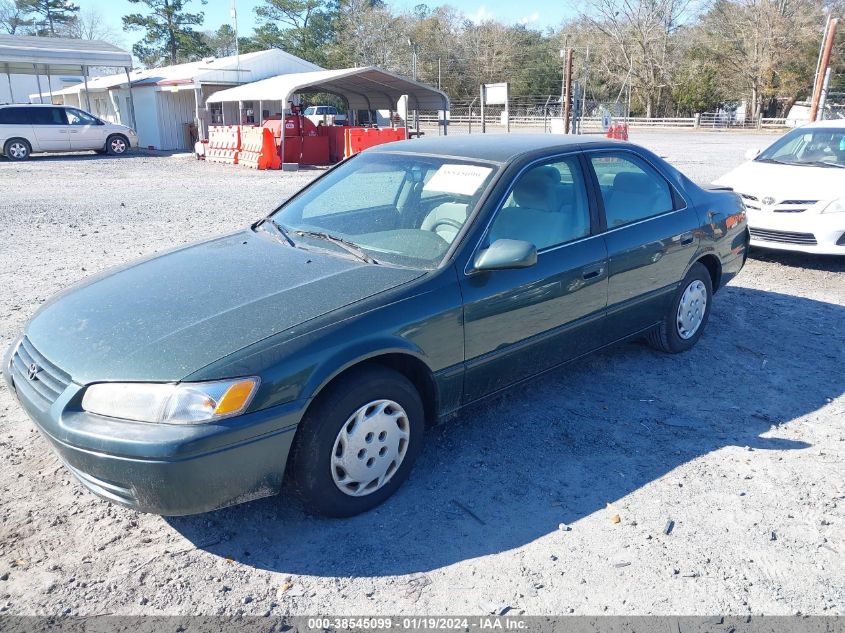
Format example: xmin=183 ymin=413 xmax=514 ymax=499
xmin=0 ymin=133 xmax=845 ymax=615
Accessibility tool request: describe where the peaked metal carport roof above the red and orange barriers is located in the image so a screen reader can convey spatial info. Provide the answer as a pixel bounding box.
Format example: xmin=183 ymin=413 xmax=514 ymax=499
xmin=208 ymin=66 xmax=449 ymax=110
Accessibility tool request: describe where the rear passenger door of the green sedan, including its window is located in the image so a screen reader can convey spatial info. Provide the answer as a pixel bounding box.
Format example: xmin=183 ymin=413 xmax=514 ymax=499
xmin=587 ymin=150 xmax=700 ymax=343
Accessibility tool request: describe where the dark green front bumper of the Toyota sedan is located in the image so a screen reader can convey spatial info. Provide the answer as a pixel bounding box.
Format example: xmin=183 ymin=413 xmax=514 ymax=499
xmin=4 ymin=346 xmax=305 ymax=516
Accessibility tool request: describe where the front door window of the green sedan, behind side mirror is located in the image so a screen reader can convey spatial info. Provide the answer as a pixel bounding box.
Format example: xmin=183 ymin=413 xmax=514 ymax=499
xmin=487 ymin=157 xmax=590 ymax=250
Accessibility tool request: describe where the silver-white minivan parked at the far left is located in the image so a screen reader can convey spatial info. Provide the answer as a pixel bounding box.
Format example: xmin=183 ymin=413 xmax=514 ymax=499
xmin=0 ymin=103 xmax=138 ymax=160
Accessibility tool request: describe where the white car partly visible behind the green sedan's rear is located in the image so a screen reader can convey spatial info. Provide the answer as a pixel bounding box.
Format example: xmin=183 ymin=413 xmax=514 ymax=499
xmin=714 ymin=120 xmax=845 ymax=255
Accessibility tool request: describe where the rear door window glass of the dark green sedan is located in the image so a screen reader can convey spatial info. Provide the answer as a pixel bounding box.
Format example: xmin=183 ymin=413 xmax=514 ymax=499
xmin=590 ymin=153 xmax=674 ymax=229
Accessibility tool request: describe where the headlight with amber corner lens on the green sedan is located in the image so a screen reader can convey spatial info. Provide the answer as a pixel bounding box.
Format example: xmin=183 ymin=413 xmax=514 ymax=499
xmin=82 ymin=378 xmax=259 ymax=424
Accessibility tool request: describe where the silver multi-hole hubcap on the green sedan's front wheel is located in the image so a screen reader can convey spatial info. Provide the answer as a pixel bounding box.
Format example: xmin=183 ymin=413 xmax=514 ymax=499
xmin=332 ymin=400 xmax=410 ymax=497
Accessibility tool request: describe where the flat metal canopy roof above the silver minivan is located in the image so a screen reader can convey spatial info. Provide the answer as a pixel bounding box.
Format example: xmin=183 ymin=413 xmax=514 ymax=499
xmin=0 ymin=35 xmax=132 ymax=75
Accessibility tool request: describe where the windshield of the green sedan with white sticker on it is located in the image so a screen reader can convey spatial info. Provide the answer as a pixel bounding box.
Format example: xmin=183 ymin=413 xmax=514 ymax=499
xmin=271 ymin=153 xmax=497 ymax=268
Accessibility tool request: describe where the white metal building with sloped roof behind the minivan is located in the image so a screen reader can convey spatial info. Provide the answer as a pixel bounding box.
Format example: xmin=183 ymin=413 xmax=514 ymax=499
xmin=36 ymin=49 xmax=321 ymax=150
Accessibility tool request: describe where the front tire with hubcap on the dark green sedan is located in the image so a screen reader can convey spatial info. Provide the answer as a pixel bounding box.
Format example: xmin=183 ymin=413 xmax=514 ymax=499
xmin=288 ymin=365 xmax=425 ymax=517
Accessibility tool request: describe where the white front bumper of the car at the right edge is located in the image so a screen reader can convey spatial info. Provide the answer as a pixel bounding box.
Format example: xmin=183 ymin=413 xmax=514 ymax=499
xmin=747 ymin=209 xmax=845 ymax=255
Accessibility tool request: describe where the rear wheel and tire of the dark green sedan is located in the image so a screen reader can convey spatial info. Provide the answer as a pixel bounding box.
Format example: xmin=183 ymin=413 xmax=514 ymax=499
xmin=648 ymin=262 xmax=713 ymax=354
